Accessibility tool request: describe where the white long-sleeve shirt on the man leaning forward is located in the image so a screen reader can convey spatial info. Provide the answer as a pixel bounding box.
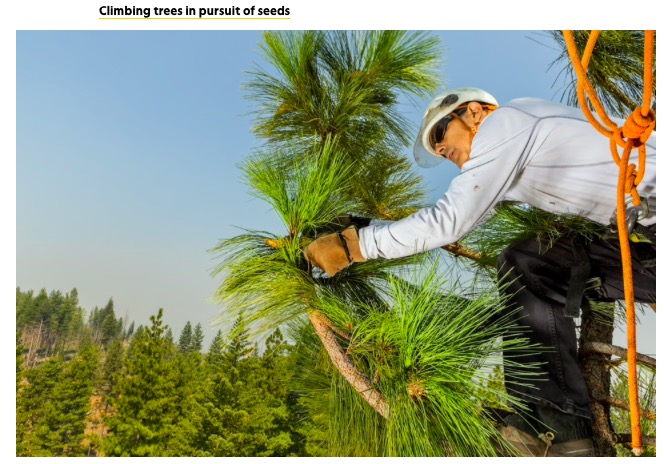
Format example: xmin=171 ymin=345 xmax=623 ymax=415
xmin=360 ymin=98 xmax=656 ymax=259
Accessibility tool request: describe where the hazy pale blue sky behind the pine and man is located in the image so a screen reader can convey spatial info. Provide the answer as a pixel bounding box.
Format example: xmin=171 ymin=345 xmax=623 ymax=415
xmin=16 ymin=31 xmax=655 ymax=354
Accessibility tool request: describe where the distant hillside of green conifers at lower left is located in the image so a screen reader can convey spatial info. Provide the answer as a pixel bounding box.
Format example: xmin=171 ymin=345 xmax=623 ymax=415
xmin=16 ymin=289 xmax=316 ymax=456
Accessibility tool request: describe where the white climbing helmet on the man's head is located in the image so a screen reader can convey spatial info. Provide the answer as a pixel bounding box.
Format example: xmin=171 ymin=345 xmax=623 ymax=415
xmin=413 ymin=87 xmax=498 ymax=168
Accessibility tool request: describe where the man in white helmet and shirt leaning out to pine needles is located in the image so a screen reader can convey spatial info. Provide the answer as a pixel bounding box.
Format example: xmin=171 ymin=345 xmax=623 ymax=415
xmin=305 ymin=88 xmax=656 ymax=456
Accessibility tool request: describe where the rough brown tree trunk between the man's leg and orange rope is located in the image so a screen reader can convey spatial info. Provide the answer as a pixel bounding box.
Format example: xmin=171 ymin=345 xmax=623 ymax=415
xmin=579 ymin=303 xmax=616 ymax=457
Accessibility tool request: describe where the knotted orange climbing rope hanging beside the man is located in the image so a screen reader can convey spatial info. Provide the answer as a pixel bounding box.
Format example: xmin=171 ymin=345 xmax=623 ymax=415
xmin=563 ymin=31 xmax=655 ymax=456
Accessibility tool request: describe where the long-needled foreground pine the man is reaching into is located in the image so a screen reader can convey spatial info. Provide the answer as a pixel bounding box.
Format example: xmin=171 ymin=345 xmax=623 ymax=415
xmin=215 ymin=31 xmax=536 ymax=456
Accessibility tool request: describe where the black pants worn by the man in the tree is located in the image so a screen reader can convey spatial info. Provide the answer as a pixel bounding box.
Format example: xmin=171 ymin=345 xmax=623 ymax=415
xmin=498 ymin=234 xmax=655 ymax=418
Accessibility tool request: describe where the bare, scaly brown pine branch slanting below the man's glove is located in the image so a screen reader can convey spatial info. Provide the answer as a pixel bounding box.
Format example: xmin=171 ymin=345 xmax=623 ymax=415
xmin=309 ymin=311 xmax=389 ymax=419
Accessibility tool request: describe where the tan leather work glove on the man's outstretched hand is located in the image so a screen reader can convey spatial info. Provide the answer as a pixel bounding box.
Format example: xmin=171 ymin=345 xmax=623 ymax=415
xmin=304 ymin=226 xmax=366 ymax=277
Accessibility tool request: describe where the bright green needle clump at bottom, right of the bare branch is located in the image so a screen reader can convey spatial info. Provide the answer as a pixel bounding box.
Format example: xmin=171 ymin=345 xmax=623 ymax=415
xmin=330 ymin=261 xmax=528 ymax=456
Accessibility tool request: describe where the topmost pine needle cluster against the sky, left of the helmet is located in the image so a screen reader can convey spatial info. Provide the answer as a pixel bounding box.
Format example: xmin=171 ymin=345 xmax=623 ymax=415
xmin=246 ymin=31 xmax=438 ymax=152
